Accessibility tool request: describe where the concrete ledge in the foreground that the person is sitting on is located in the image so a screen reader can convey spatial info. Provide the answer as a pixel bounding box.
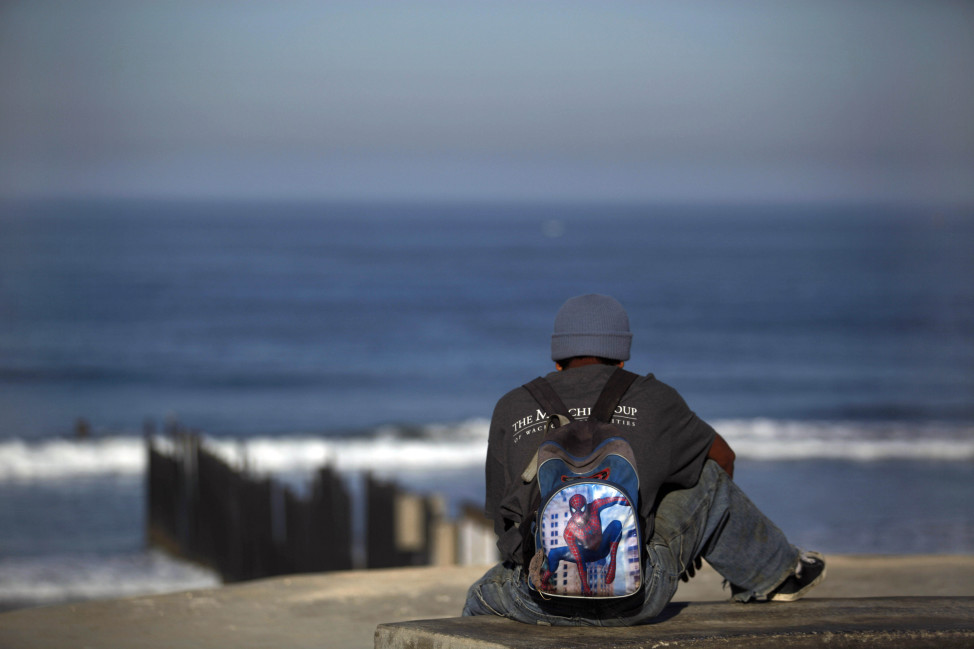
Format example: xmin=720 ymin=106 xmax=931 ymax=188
xmin=375 ymin=597 xmax=974 ymax=649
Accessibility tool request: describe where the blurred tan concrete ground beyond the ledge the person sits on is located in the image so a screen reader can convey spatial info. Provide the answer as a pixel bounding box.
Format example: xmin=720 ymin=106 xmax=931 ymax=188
xmin=0 ymin=556 xmax=974 ymax=649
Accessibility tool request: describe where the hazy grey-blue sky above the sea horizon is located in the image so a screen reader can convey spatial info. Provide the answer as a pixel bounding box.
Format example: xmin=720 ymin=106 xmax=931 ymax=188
xmin=0 ymin=0 xmax=974 ymax=201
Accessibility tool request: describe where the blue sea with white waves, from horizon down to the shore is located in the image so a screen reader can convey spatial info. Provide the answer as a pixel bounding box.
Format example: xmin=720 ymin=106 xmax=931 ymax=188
xmin=0 ymin=201 xmax=974 ymax=608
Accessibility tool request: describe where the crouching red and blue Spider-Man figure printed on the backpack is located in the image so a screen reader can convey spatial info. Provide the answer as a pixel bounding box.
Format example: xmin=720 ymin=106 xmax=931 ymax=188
xmin=541 ymin=494 xmax=628 ymax=595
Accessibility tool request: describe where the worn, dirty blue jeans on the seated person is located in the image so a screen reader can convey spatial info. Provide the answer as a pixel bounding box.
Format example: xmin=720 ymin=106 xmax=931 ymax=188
xmin=463 ymin=460 xmax=799 ymax=626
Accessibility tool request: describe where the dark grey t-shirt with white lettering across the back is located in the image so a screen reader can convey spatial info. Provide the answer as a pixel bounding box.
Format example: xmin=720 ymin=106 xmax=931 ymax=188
xmin=486 ymin=365 xmax=715 ymax=563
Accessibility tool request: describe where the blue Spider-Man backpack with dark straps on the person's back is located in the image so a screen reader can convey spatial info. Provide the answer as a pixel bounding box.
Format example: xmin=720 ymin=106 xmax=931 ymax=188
xmin=521 ymin=368 xmax=643 ymax=598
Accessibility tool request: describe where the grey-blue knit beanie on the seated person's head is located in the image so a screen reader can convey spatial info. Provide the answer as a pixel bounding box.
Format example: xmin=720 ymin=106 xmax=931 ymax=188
xmin=551 ymin=295 xmax=632 ymax=362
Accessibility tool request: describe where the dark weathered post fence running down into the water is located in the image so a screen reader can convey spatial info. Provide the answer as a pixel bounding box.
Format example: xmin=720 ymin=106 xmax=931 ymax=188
xmin=146 ymin=431 xmax=495 ymax=582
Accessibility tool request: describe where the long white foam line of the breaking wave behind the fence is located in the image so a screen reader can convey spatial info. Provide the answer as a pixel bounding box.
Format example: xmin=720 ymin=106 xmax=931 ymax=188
xmin=0 ymin=419 xmax=974 ymax=482
